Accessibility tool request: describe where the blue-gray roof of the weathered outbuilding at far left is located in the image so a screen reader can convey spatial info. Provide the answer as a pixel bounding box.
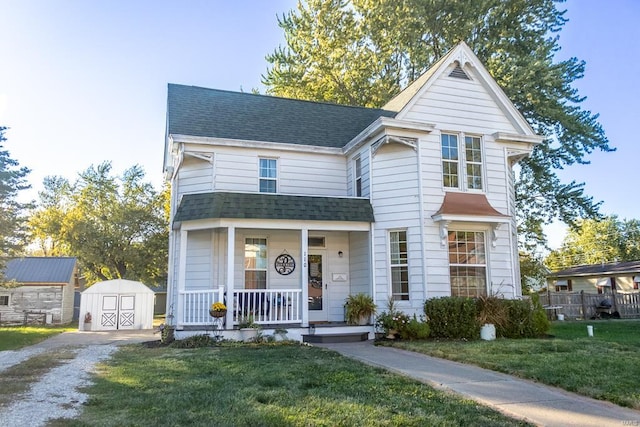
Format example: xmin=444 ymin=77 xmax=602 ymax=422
xmin=5 ymin=257 xmax=76 ymax=283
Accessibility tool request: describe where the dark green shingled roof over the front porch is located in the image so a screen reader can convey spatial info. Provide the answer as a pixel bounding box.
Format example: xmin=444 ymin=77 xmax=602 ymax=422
xmin=174 ymin=192 xmax=374 ymax=222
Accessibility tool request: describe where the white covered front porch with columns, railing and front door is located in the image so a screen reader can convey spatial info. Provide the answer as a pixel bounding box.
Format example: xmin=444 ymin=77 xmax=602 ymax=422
xmin=169 ymin=191 xmax=373 ymax=337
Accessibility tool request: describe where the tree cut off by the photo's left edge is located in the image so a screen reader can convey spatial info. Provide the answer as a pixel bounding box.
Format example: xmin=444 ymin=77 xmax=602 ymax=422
xmin=0 ymin=127 xmax=30 ymax=282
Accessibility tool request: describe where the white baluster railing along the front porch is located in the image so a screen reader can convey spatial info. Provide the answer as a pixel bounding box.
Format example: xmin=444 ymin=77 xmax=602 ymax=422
xmin=178 ymin=288 xmax=302 ymax=326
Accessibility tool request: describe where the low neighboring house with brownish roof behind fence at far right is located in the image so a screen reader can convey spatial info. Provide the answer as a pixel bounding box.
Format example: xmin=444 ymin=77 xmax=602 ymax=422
xmin=547 ymin=261 xmax=640 ymax=294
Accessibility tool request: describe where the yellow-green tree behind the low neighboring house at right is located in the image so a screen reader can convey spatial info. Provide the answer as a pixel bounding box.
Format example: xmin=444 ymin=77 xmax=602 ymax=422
xmin=545 ymin=215 xmax=640 ymax=270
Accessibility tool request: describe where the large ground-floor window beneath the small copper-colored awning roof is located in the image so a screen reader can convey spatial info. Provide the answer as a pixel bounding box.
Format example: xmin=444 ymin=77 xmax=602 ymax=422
xmin=449 ymin=231 xmax=487 ymax=298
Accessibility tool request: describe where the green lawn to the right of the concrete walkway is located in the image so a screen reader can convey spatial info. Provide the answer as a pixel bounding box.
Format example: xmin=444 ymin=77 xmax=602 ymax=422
xmin=390 ymin=320 xmax=640 ymax=409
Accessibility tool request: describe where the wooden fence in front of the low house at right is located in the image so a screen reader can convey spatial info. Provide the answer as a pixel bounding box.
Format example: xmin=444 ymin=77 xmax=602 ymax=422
xmin=540 ymin=291 xmax=640 ymax=319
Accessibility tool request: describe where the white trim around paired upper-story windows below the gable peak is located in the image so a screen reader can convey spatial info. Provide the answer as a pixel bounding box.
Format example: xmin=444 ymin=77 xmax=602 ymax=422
xmin=440 ymin=130 xmax=487 ymax=192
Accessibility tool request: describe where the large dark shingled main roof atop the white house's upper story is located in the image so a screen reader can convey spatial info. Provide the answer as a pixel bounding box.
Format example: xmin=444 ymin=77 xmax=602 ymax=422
xmin=167 ymin=84 xmax=396 ymax=148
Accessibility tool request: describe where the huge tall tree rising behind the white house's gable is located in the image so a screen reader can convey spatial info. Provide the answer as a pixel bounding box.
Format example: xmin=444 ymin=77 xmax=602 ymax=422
xmin=262 ymin=0 xmax=613 ymax=249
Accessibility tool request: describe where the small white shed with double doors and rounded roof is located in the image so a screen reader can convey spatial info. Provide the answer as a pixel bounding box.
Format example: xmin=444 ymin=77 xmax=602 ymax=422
xmin=78 ymin=279 xmax=154 ymax=331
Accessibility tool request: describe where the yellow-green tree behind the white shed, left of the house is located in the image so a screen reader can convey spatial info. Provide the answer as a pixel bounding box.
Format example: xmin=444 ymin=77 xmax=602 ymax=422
xmin=30 ymin=162 xmax=168 ymax=284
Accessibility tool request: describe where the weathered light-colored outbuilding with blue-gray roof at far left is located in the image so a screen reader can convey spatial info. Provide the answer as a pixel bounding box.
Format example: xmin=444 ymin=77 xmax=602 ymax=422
xmin=0 ymin=257 xmax=78 ymax=323
